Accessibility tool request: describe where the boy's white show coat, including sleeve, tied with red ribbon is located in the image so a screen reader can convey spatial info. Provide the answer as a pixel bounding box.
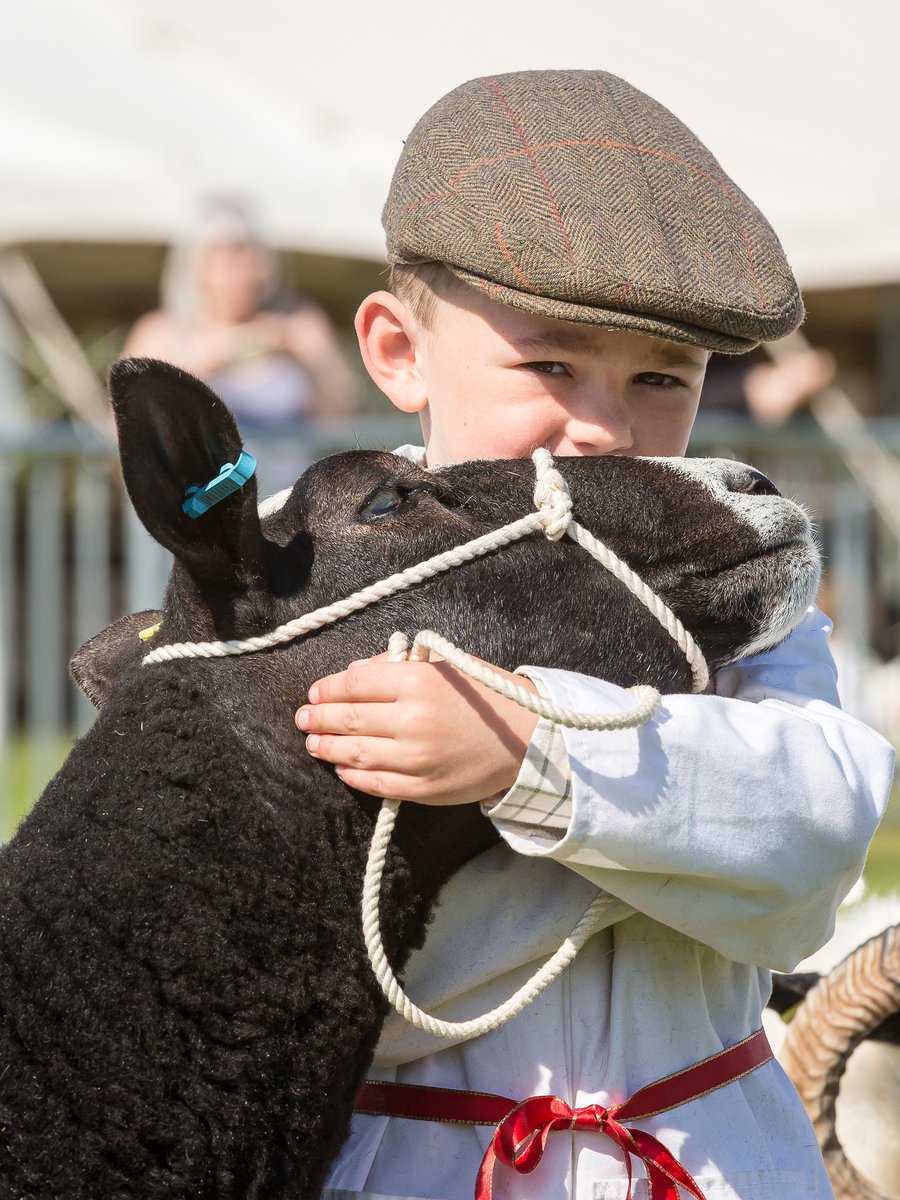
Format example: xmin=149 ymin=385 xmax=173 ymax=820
xmin=323 ymin=448 xmax=893 ymax=1200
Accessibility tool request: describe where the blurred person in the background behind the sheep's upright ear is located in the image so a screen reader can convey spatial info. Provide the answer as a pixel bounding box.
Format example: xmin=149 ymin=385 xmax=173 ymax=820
xmin=122 ymin=203 xmax=360 ymax=487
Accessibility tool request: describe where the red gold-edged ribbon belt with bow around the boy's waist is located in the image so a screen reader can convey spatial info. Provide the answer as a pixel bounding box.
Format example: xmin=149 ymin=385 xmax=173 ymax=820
xmin=353 ymin=1030 xmax=774 ymax=1200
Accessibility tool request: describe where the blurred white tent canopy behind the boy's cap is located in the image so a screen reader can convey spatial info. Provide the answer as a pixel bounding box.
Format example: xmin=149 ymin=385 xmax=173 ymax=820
xmin=0 ymin=0 xmax=900 ymax=287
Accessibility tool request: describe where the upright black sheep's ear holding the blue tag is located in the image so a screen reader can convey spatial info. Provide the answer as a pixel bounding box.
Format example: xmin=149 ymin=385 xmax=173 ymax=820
xmin=109 ymin=359 xmax=263 ymax=588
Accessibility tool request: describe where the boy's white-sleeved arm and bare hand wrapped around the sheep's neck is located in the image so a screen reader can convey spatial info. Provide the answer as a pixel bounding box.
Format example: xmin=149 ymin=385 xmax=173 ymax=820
xmin=301 ymin=448 xmax=894 ymax=971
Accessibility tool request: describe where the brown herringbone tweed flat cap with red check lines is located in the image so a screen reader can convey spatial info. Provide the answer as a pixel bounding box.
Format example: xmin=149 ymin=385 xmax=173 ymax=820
xmin=383 ymin=71 xmax=803 ymax=354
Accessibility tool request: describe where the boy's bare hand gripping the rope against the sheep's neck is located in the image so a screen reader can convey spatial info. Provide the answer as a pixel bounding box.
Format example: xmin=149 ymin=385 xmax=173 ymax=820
xmin=294 ymin=654 xmax=538 ymax=804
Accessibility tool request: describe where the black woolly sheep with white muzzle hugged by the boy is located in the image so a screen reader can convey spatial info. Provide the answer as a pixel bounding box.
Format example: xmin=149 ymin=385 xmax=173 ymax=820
xmin=0 ymin=361 xmax=816 ymax=1200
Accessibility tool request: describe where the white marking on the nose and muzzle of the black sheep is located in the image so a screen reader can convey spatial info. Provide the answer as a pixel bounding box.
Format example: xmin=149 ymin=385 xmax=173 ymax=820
xmin=653 ymin=458 xmax=820 ymax=658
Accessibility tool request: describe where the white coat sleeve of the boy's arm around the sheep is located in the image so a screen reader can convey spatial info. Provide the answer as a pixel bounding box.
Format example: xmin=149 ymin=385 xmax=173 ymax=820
xmin=497 ymin=608 xmax=894 ymax=971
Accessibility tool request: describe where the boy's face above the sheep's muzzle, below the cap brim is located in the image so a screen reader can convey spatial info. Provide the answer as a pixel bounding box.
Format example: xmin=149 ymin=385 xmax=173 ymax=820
xmin=413 ymin=289 xmax=709 ymax=466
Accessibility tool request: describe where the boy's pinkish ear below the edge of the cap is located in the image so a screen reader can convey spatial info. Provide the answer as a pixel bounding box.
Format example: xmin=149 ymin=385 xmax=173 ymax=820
xmin=354 ymin=292 xmax=428 ymax=413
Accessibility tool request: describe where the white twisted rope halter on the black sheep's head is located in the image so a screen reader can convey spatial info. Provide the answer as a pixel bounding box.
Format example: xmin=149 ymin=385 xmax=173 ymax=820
xmin=143 ymin=449 xmax=709 ymax=1040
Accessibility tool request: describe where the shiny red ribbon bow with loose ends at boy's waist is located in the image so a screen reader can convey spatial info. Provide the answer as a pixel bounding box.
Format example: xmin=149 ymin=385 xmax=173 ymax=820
xmin=475 ymin=1096 xmax=704 ymax=1200
